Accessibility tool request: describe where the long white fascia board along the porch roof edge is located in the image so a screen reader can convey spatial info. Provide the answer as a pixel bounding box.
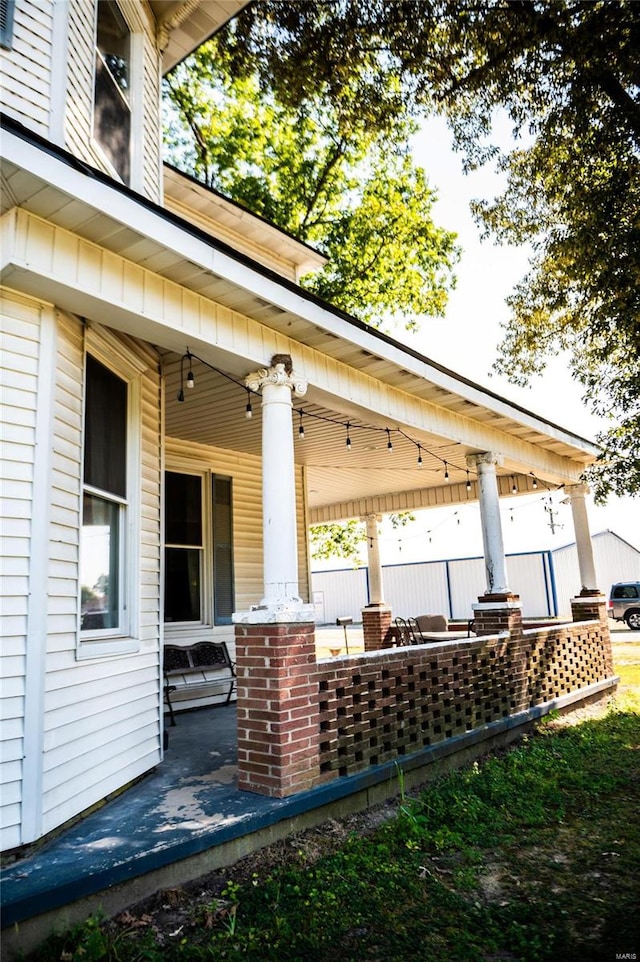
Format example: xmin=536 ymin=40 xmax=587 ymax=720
xmin=2 ymin=131 xmax=599 ymax=456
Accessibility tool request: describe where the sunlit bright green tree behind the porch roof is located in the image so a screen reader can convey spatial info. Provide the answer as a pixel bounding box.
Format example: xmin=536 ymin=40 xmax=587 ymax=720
xmin=165 ymin=40 xmax=458 ymax=328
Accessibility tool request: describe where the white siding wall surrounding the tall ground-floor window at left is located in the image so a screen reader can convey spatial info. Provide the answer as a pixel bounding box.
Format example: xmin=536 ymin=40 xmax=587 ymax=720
xmin=37 ymin=315 xmax=161 ymax=842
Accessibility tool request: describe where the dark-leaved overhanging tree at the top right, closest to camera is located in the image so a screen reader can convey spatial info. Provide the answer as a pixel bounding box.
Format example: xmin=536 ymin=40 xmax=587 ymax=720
xmin=214 ymin=0 xmax=640 ymax=500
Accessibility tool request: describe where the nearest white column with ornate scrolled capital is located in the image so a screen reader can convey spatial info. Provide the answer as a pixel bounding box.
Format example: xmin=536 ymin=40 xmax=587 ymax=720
xmin=234 ymin=354 xmax=315 ymax=622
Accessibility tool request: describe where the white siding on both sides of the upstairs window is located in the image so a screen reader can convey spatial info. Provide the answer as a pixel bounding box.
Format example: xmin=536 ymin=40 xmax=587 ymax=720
xmin=66 ymin=0 xmax=161 ymax=202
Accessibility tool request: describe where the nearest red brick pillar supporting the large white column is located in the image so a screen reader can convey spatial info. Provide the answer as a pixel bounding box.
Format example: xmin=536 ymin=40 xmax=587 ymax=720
xmin=235 ymin=622 xmax=320 ymax=798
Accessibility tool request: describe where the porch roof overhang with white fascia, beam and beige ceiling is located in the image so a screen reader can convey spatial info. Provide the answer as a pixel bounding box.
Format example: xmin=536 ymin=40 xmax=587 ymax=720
xmin=2 ymin=121 xmax=597 ymax=522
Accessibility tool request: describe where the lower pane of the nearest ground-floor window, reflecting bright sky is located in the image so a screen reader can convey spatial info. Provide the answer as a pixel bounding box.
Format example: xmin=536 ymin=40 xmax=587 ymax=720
xmin=80 ymin=494 xmax=122 ymax=631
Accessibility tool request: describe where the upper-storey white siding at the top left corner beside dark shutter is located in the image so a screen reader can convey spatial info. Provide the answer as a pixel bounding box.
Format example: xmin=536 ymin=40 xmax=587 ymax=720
xmin=0 ymin=0 xmax=53 ymax=137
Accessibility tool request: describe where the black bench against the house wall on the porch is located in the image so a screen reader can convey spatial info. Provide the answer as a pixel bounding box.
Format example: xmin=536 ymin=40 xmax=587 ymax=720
xmin=164 ymin=641 xmax=236 ymax=725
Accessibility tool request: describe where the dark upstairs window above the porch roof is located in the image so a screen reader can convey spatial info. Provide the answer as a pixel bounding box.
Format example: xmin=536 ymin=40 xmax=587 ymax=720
xmin=93 ymin=0 xmax=131 ymax=184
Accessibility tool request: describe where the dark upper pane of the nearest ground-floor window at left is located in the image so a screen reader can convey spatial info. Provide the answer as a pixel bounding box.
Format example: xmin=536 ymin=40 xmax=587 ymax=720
xmin=84 ymin=356 xmax=127 ymax=498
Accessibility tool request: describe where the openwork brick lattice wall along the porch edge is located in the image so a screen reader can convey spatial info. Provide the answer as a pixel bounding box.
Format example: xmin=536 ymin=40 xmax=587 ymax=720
xmin=317 ymin=621 xmax=613 ymax=781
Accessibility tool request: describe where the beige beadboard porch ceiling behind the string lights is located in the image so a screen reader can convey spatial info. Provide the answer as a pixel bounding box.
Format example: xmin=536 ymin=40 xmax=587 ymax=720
xmin=163 ymin=352 xmax=564 ymax=523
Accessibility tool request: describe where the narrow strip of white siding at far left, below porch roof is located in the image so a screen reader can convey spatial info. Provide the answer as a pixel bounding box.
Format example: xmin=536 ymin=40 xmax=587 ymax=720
xmin=0 ymin=291 xmax=41 ymax=851
